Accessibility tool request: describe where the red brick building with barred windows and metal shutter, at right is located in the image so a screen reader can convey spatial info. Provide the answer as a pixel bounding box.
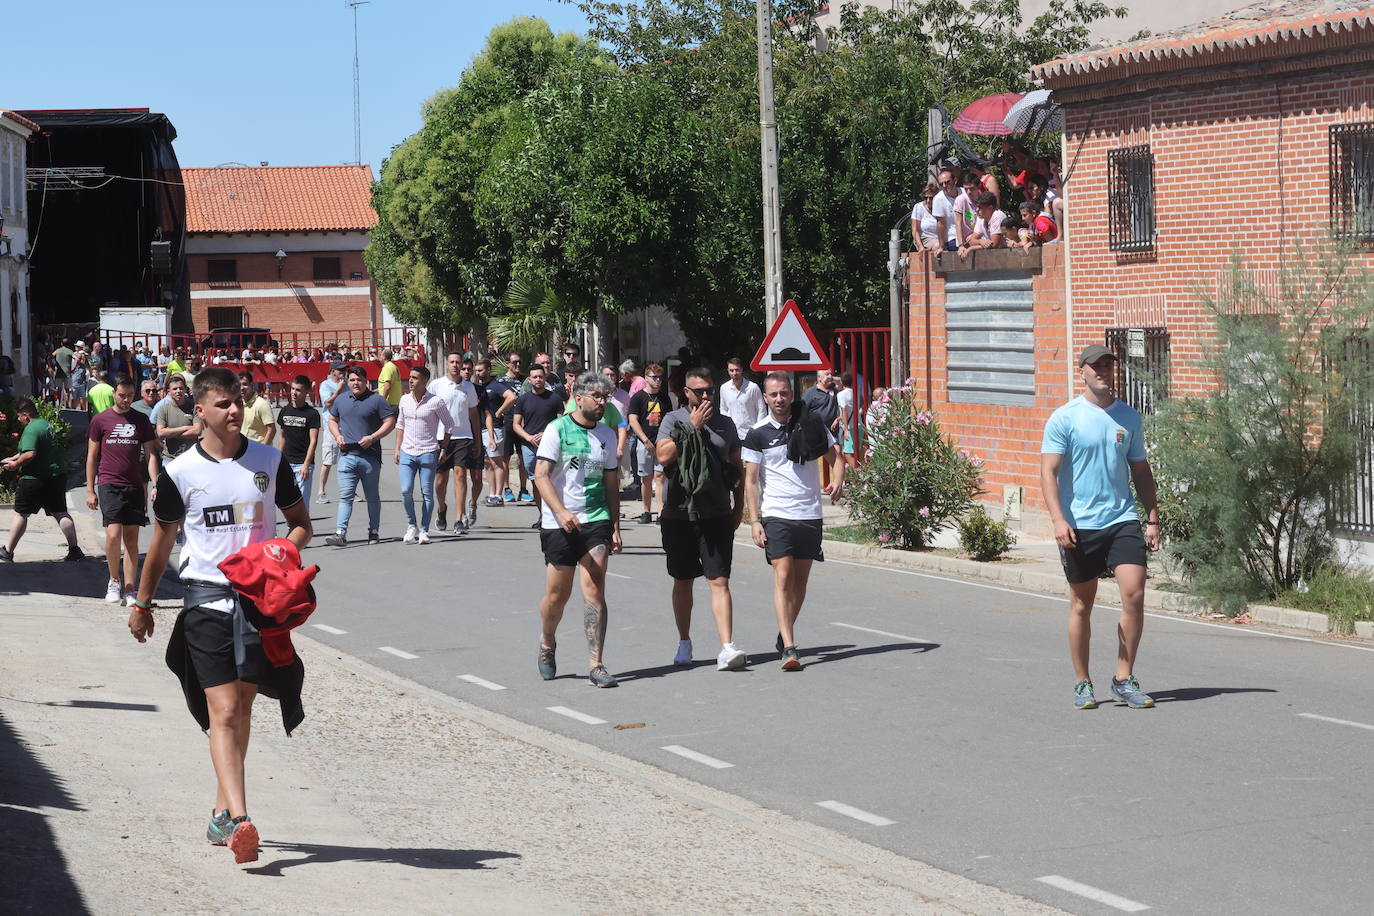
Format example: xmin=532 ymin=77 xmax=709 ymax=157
xmin=908 ymin=0 xmax=1374 ymax=529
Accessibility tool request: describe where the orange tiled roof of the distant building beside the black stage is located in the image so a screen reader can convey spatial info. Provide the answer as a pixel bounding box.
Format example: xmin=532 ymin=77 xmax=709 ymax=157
xmin=181 ymin=165 xmax=376 ymax=232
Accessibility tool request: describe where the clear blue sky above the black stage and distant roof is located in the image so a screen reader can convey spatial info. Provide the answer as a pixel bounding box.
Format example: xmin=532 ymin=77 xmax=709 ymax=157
xmin=0 ymin=0 xmax=585 ymax=174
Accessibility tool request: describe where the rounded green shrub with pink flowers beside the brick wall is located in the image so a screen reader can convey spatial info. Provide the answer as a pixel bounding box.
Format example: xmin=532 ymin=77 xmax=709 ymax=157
xmin=846 ymin=380 xmax=982 ymax=548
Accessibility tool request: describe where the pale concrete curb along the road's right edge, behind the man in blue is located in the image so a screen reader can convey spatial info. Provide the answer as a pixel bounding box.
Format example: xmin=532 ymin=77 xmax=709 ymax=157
xmin=822 ymin=538 xmax=1374 ymax=639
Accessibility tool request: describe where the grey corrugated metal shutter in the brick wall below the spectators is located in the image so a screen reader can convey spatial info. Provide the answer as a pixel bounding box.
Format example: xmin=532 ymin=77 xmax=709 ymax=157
xmin=945 ymin=271 xmax=1035 ymax=407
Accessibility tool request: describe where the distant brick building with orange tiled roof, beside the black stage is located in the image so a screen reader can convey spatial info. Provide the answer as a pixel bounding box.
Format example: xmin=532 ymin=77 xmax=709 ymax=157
xmin=181 ymin=165 xmax=382 ymax=334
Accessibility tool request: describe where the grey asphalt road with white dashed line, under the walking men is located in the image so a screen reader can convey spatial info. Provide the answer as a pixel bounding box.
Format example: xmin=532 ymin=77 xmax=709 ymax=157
xmin=289 ymin=444 xmax=1374 ymax=913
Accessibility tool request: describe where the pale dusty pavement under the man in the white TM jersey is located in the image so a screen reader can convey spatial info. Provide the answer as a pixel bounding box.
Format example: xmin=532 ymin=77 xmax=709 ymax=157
xmin=0 ymin=512 xmax=1057 ymax=913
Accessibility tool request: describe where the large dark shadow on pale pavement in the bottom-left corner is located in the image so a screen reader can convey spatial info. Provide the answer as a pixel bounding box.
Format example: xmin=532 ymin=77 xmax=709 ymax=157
xmin=0 ymin=713 xmax=89 ymax=913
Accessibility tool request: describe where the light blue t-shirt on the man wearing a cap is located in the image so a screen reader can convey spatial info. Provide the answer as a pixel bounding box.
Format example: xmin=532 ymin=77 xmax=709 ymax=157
xmin=1040 ymin=397 xmax=1145 ymax=531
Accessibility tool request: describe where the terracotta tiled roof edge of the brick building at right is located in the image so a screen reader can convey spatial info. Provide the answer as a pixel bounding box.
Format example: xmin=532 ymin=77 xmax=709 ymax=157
xmin=1031 ymin=0 xmax=1374 ymax=88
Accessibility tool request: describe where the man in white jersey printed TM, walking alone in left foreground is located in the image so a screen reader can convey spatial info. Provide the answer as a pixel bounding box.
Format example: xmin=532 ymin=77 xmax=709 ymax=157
xmin=129 ymin=367 xmax=312 ymax=862
